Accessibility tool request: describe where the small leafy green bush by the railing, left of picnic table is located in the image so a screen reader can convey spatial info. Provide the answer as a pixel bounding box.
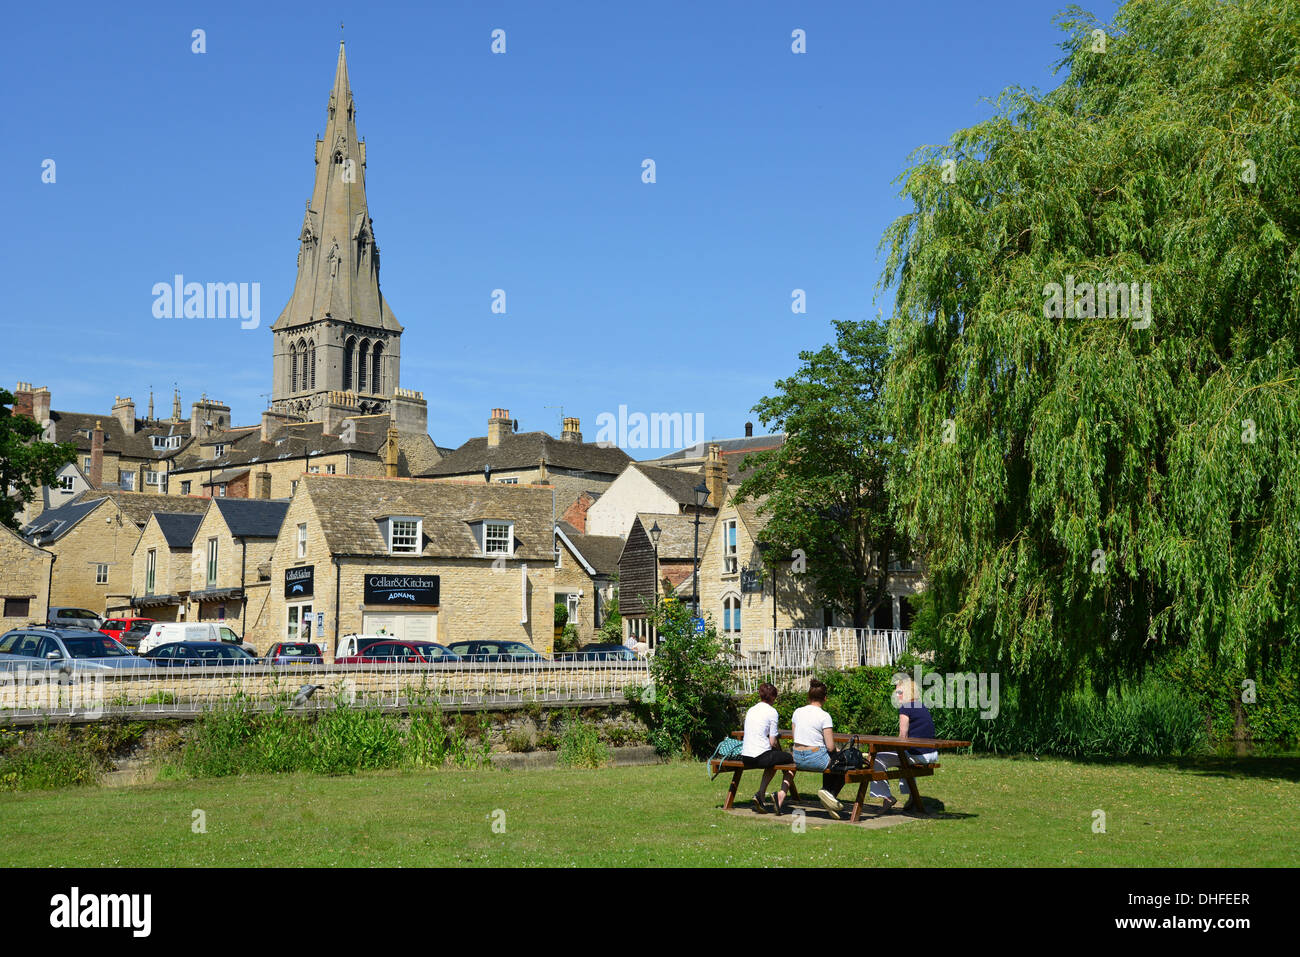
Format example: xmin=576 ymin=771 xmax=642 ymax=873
xmin=633 ymin=598 xmax=735 ymax=757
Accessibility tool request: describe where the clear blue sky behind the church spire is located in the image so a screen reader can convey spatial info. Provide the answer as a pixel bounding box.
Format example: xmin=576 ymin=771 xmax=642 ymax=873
xmin=0 ymin=0 xmax=1114 ymax=458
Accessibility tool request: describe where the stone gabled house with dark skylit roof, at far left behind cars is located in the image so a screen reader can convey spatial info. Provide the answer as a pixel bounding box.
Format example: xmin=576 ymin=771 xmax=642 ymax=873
xmin=22 ymin=489 xmax=208 ymax=615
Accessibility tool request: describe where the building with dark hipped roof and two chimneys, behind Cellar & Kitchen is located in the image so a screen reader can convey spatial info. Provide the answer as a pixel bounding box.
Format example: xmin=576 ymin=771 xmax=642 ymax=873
xmin=419 ymin=408 xmax=632 ymax=520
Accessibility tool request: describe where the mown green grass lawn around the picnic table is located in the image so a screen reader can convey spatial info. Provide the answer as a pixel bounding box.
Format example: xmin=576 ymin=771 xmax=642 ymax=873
xmin=0 ymin=755 xmax=1300 ymax=867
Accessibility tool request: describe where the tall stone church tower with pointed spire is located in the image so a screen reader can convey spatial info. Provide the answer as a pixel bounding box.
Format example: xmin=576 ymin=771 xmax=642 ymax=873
xmin=270 ymin=43 xmax=428 ymax=432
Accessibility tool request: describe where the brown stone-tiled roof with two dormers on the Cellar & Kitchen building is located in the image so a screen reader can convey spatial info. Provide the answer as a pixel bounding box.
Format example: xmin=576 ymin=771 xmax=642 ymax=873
xmin=298 ymin=475 xmax=555 ymax=563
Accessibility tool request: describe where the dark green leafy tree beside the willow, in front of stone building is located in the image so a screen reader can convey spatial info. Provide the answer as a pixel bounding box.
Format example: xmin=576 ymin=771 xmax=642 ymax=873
xmin=737 ymin=315 xmax=910 ymax=628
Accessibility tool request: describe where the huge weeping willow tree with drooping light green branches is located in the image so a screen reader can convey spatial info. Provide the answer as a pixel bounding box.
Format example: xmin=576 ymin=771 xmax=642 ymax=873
xmin=881 ymin=0 xmax=1300 ymax=689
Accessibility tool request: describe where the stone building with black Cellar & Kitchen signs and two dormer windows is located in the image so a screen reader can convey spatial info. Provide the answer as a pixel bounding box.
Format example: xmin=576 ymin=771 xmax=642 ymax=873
xmin=244 ymin=475 xmax=555 ymax=654
